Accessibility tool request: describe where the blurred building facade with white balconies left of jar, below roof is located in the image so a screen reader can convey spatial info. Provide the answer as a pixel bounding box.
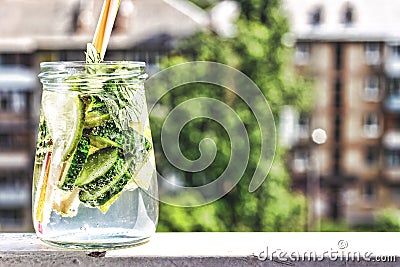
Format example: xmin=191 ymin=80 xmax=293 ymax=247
xmin=0 ymin=63 xmax=37 ymax=231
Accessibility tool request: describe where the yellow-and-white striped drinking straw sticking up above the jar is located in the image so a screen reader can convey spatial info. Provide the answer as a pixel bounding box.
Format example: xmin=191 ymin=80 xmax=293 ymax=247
xmin=92 ymin=0 xmax=121 ymax=60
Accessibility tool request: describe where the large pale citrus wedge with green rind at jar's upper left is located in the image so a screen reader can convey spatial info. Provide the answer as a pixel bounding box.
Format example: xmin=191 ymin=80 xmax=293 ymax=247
xmin=42 ymin=90 xmax=84 ymax=161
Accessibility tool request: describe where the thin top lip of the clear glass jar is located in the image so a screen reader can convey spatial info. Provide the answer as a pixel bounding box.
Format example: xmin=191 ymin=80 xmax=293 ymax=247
xmin=40 ymin=60 xmax=146 ymax=68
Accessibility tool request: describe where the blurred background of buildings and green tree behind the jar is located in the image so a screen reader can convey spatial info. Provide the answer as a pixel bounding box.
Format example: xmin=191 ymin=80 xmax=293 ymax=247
xmin=0 ymin=0 xmax=400 ymax=232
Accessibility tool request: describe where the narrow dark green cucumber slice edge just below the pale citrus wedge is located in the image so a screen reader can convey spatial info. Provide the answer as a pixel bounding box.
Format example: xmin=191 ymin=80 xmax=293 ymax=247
xmin=59 ymin=136 xmax=90 ymax=191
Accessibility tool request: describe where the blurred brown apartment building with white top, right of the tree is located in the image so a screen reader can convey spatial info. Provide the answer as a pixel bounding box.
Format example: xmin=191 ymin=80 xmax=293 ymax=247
xmin=283 ymin=0 xmax=400 ymax=225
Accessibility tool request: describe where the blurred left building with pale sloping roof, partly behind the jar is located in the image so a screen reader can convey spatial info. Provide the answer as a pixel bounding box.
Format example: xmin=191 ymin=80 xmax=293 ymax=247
xmin=0 ymin=0 xmax=210 ymax=232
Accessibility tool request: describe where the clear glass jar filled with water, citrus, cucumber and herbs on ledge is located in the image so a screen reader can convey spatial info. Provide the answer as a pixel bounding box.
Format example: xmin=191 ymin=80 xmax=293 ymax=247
xmin=32 ymin=61 xmax=158 ymax=249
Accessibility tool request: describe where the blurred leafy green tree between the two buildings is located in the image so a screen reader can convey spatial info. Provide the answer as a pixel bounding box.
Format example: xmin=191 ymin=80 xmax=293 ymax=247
xmin=152 ymin=0 xmax=311 ymax=231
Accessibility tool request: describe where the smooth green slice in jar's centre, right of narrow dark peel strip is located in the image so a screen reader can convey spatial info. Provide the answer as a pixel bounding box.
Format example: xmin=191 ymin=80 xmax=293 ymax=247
xmin=75 ymin=148 xmax=119 ymax=187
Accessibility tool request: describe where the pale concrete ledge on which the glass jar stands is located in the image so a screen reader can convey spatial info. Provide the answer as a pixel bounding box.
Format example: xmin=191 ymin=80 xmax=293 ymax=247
xmin=0 ymin=233 xmax=400 ymax=267
